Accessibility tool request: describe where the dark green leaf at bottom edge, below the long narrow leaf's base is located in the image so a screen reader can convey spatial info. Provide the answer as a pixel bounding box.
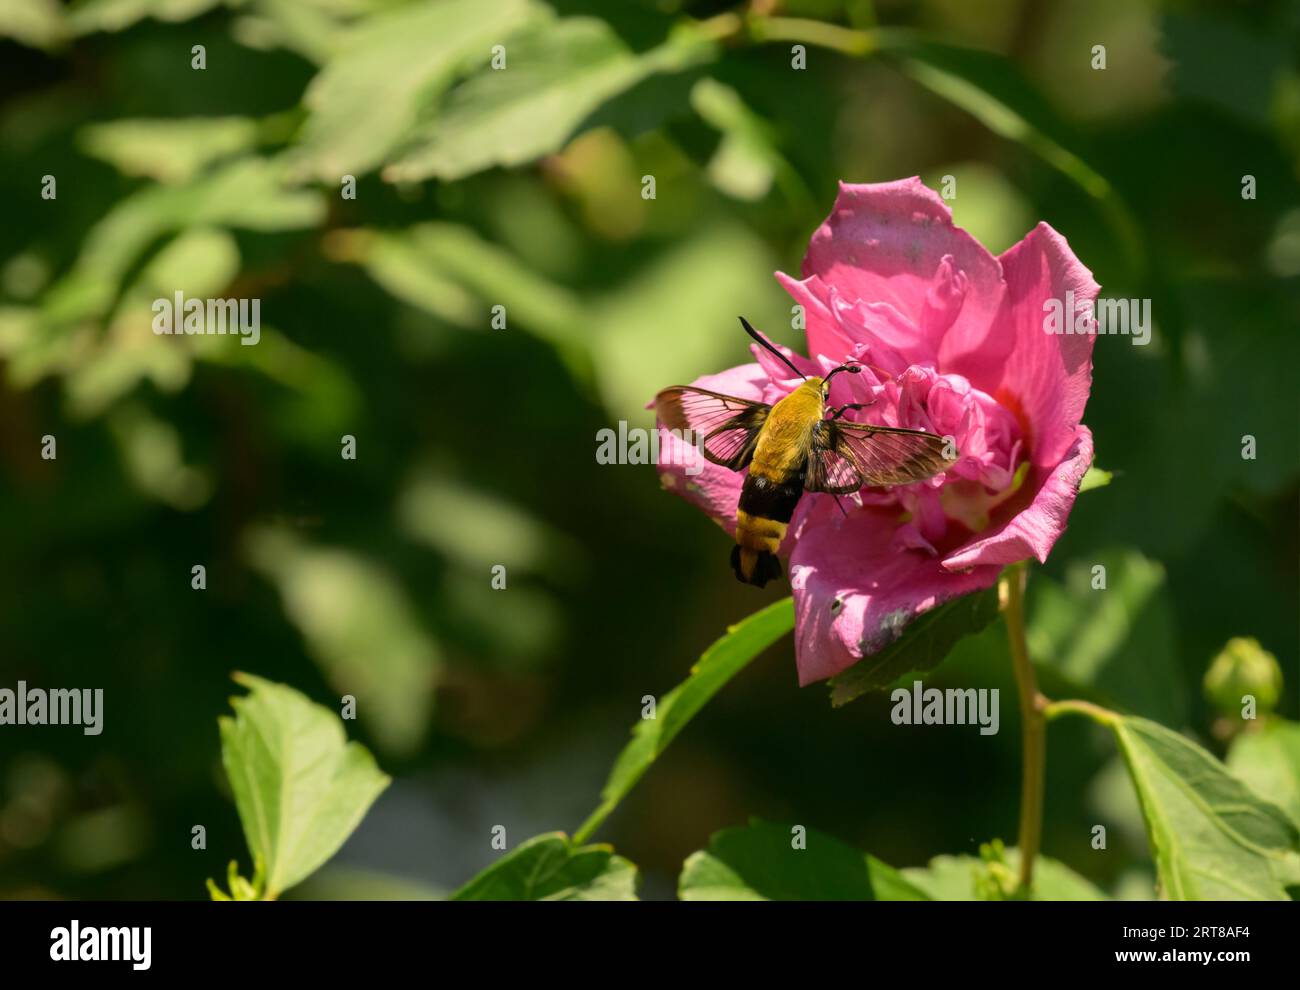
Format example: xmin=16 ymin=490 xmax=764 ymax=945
xmin=451 ymin=831 xmax=637 ymax=900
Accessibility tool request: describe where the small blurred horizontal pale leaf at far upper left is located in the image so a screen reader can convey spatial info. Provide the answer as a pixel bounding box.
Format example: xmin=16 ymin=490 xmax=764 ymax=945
xmin=78 ymin=117 xmax=257 ymax=183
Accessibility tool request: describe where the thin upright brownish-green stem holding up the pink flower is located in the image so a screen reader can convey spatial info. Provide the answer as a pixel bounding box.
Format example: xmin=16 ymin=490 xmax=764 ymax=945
xmin=998 ymin=565 xmax=1048 ymax=893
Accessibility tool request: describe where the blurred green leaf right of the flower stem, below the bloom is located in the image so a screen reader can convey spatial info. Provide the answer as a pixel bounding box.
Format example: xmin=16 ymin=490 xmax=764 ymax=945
xmin=1026 ymin=550 xmax=1187 ymax=725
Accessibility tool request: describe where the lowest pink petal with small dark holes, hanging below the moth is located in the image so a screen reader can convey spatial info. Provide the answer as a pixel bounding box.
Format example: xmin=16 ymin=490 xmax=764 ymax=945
xmin=790 ymin=496 xmax=998 ymax=686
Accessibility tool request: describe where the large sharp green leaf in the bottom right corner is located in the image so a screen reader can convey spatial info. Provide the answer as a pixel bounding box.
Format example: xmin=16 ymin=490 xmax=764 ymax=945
xmin=1110 ymin=717 xmax=1300 ymax=900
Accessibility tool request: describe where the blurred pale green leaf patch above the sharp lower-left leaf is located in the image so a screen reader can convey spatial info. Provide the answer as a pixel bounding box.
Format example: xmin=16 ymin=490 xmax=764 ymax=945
xmin=247 ymin=527 xmax=441 ymax=754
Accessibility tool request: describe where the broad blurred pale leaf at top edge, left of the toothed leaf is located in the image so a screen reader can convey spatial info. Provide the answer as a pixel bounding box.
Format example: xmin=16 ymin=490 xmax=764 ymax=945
xmin=291 ymin=0 xmax=545 ymax=186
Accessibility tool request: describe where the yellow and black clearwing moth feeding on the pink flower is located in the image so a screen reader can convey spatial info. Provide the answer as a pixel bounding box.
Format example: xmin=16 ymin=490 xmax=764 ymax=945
xmin=654 ymin=317 xmax=956 ymax=587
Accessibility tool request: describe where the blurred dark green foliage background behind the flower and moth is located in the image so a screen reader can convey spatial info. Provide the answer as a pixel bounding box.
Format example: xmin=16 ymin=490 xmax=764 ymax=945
xmin=0 ymin=0 xmax=1300 ymax=898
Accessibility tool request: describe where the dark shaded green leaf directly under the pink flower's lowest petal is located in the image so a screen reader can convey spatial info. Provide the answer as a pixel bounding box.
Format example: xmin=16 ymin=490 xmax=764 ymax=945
xmin=831 ymin=586 xmax=997 ymax=707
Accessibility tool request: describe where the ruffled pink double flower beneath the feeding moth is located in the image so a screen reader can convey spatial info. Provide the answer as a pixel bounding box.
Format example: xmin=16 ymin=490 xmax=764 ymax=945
xmin=659 ymin=178 xmax=1099 ymax=685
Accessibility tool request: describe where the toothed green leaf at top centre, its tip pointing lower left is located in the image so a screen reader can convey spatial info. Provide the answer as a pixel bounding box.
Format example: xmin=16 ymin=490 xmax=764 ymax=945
xmin=384 ymin=17 xmax=712 ymax=182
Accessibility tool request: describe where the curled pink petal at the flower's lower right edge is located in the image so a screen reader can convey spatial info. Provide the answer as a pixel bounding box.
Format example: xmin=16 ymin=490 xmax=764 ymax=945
xmin=944 ymin=426 xmax=1092 ymax=570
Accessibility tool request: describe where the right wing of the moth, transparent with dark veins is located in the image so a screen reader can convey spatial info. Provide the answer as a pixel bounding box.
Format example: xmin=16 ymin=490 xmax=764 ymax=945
xmin=803 ymin=420 xmax=953 ymax=495
